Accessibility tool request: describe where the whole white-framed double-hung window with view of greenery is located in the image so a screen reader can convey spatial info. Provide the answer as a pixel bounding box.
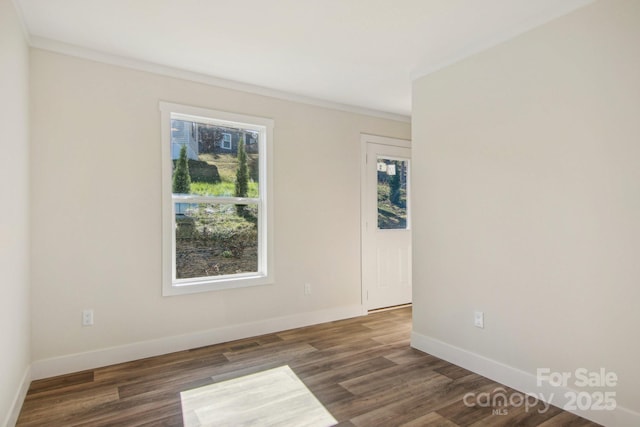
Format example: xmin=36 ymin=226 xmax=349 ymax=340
xmin=160 ymin=102 xmax=274 ymax=295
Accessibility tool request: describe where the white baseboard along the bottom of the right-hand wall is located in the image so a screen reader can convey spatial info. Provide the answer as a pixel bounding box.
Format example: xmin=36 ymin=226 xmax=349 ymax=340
xmin=411 ymin=332 xmax=640 ymax=427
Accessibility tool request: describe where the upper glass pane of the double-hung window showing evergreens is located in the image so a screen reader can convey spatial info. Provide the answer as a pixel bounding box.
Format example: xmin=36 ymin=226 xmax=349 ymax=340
xmin=171 ymin=119 xmax=260 ymax=198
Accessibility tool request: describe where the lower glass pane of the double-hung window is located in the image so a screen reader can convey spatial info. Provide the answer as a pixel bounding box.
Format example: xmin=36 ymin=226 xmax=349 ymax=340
xmin=175 ymin=203 xmax=258 ymax=279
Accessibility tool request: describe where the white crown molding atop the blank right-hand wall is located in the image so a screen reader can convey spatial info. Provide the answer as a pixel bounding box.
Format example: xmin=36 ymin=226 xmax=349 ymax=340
xmin=411 ymin=0 xmax=595 ymax=81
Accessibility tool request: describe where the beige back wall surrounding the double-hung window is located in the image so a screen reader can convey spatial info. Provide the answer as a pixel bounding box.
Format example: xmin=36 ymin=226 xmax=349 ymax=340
xmin=31 ymin=49 xmax=410 ymax=368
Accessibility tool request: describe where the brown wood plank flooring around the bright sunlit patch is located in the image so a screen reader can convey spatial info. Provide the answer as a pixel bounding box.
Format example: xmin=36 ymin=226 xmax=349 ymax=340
xmin=17 ymin=307 xmax=597 ymax=427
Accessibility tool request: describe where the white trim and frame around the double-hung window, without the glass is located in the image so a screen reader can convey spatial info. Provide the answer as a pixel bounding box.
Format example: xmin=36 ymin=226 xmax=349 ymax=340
xmin=159 ymin=101 xmax=275 ymax=296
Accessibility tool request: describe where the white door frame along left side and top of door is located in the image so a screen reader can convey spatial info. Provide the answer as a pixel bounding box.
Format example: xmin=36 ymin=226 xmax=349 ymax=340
xmin=360 ymin=133 xmax=411 ymax=314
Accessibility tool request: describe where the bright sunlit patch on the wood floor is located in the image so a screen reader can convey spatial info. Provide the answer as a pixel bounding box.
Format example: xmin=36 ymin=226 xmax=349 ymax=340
xmin=180 ymin=366 xmax=338 ymax=427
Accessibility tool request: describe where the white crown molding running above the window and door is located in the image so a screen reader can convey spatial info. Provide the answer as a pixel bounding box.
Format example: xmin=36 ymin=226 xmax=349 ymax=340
xmin=28 ymin=35 xmax=411 ymax=123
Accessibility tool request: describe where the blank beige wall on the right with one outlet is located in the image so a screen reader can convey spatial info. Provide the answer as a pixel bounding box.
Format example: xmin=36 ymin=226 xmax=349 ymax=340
xmin=412 ymin=0 xmax=640 ymax=418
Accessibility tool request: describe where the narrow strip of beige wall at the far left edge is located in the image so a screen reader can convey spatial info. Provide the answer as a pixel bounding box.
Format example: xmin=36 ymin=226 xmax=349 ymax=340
xmin=0 ymin=0 xmax=30 ymax=423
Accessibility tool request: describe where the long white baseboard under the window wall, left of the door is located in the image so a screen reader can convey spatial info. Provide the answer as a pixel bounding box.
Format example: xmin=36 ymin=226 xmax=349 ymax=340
xmin=31 ymin=305 xmax=367 ymax=380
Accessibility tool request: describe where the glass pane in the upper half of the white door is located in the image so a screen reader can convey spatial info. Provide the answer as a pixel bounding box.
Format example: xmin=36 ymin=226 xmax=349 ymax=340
xmin=377 ymin=157 xmax=409 ymax=229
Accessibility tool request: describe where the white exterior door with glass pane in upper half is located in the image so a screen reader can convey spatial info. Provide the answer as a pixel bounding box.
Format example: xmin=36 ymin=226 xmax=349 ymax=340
xmin=361 ymin=135 xmax=411 ymax=310
